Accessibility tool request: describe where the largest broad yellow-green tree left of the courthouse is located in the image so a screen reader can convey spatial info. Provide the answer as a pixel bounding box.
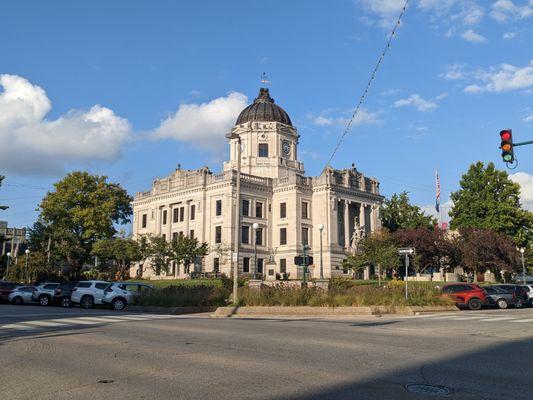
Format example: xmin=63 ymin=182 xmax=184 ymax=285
xmin=39 ymin=172 xmax=132 ymax=277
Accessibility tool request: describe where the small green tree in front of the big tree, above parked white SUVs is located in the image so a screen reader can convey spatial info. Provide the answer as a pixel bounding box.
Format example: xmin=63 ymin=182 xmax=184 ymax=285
xmin=91 ymin=236 xmax=143 ymax=280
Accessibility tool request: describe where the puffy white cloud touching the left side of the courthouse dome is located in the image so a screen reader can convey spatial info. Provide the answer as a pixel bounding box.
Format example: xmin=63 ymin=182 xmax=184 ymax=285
xmin=152 ymin=92 xmax=248 ymax=151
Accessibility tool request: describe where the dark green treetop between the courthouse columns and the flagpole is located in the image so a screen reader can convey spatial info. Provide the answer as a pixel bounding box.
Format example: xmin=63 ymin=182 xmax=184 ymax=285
xmin=381 ymin=192 xmax=437 ymax=233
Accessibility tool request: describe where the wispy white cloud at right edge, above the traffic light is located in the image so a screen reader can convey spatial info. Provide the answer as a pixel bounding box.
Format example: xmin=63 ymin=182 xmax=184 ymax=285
xmin=464 ymin=60 xmax=533 ymax=93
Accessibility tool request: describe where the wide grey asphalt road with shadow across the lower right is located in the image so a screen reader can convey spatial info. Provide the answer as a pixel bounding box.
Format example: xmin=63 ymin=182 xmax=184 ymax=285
xmin=0 ymin=305 xmax=533 ymax=400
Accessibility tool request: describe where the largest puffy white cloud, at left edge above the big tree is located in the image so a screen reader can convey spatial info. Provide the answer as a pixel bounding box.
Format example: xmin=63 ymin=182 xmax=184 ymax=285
xmin=0 ymin=75 xmax=131 ymax=175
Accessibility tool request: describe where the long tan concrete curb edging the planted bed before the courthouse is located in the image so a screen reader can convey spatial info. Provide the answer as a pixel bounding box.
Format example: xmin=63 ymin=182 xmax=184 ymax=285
xmin=211 ymin=305 xmax=459 ymax=318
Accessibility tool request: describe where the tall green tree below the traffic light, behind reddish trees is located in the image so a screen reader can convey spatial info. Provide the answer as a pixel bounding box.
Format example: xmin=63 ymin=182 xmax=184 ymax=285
xmin=450 ymin=161 xmax=533 ymax=246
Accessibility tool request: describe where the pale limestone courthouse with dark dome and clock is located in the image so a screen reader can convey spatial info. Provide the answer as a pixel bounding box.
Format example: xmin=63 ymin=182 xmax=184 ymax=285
xmin=132 ymin=88 xmax=383 ymax=279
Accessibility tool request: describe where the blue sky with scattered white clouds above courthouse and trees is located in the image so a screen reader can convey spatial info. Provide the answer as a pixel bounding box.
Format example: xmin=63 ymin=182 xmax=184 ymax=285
xmin=0 ymin=0 xmax=533 ymax=226
